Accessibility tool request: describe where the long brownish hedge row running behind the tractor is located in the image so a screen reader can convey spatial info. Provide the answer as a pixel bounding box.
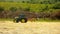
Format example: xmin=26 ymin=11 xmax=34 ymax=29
xmin=0 ymin=9 xmax=60 ymax=19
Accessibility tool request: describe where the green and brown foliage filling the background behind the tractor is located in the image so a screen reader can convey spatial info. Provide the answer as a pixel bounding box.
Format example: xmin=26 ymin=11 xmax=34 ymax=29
xmin=0 ymin=0 xmax=60 ymax=19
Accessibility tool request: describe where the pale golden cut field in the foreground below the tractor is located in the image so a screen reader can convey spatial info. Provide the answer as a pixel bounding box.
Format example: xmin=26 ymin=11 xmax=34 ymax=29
xmin=0 ymin=21 xmax=60 ymax=34
